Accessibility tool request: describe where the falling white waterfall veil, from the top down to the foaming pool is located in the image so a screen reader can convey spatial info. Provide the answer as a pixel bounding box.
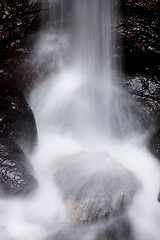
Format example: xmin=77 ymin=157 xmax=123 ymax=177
xmin=32 ymin=0 xmax=136 ymax=142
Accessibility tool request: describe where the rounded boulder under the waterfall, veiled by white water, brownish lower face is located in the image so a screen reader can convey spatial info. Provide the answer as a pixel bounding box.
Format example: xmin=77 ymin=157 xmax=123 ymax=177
xmin=49 ymin=152 xmax=135 ymax=240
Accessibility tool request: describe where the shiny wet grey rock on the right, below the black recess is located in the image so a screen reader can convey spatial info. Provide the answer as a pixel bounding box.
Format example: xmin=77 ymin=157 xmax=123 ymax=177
xmin=120 ymin=74 xmax=160 ymax=159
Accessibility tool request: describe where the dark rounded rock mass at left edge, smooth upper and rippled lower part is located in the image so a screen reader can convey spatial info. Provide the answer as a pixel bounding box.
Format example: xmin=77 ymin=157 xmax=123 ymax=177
xmin=0 ymin=77 xmax=37 ymax=194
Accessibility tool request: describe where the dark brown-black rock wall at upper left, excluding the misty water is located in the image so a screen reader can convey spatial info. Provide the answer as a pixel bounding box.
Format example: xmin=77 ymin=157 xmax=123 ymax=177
xmin=0 ymin=0 xmax=41 ymax=90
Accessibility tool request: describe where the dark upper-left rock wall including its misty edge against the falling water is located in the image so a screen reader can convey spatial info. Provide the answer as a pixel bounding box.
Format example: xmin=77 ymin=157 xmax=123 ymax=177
xmin=0 ymin=0 xmax=70 ymax=92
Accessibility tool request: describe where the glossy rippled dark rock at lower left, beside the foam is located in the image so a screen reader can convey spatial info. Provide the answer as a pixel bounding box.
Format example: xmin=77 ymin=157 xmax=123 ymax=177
xmin=0 ymin=137 xmax=37 ymax=196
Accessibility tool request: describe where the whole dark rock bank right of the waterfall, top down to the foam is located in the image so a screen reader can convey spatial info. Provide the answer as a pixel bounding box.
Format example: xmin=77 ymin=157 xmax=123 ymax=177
xmin=119 ymin=0 xmax=160 ymax=158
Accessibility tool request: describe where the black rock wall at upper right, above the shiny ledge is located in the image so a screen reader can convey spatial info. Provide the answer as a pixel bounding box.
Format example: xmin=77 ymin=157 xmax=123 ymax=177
xmin=121 ymin=0 xmax=160 ymax=75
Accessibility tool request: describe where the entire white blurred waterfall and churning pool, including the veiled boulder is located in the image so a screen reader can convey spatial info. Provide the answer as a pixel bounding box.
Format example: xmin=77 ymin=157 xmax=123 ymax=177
xmin=0 ymin=0 xmax=160 ymax=240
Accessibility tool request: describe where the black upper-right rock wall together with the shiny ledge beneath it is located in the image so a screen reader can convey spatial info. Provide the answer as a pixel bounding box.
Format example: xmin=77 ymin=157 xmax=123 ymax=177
xmin=120 ymin=0 xmax=160 ymax=110
